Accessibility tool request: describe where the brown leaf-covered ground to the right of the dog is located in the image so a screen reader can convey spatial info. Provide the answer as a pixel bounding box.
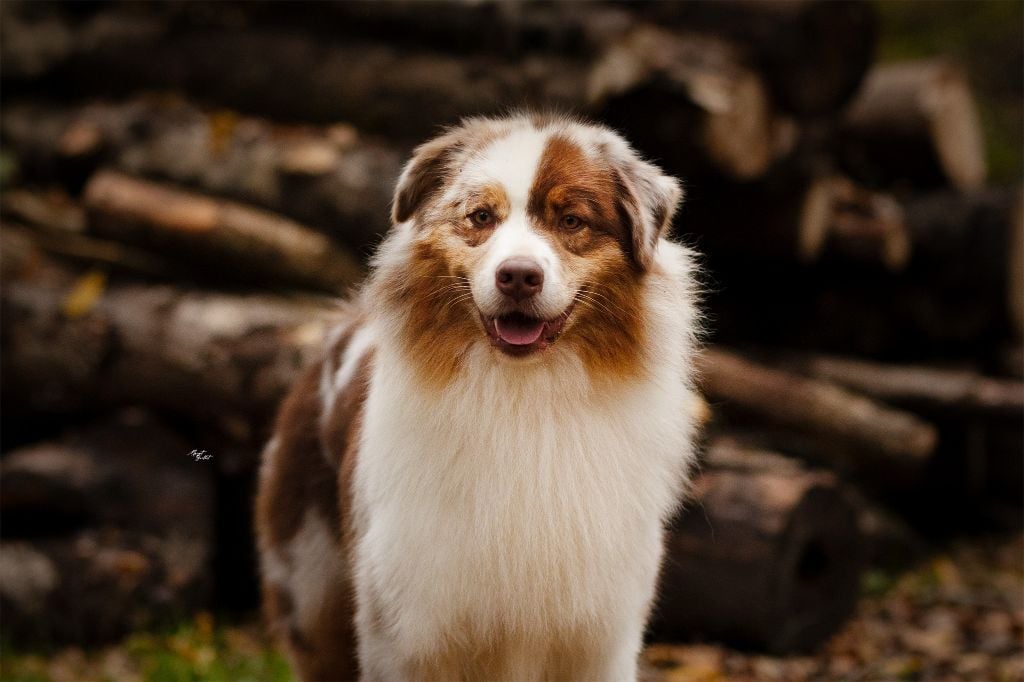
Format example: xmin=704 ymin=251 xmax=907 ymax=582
xmin=645 ymin=534 xmax=1024 ymax=682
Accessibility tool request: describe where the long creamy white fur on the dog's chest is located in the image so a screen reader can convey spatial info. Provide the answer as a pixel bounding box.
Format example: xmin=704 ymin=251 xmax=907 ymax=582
xmin=355 ymin=337 xmax=690 ymax=653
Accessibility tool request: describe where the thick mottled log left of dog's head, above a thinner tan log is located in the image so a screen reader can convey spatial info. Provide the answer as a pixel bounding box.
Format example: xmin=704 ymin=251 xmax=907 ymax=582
xmin=2 ymin=97 xmax=403 ymax=253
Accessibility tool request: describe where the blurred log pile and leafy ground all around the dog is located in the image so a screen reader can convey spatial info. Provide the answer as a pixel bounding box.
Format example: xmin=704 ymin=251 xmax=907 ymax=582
xmin=0 ymin=0 xmax=1024 ymax=680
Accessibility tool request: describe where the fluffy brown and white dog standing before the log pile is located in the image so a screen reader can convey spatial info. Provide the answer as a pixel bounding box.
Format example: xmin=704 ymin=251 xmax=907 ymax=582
xmin=256 ymin=115 xmax=698 ymax=682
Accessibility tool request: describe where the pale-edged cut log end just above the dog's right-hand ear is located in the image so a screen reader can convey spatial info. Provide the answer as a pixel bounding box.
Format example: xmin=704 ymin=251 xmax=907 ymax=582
xmin=587 ymin=26 xmax=797 ymax=180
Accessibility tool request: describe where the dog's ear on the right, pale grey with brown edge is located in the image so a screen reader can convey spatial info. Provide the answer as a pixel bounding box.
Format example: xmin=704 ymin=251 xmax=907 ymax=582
xmin=615 ymin=154 xmax=683 ymax=270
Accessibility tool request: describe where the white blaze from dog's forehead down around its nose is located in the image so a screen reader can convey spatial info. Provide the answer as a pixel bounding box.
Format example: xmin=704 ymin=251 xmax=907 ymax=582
xmin=464 ymin=129 xmax=572 ymax=318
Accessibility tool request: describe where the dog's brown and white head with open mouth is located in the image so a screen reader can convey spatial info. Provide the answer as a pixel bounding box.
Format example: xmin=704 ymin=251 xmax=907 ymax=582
xmin=376 ymin=117 xmax=682 ymax=382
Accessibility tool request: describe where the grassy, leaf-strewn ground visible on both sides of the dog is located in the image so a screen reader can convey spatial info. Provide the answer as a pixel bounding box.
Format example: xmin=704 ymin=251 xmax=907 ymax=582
xmin=0 ymin=534 xmax=1024 ymax=682
